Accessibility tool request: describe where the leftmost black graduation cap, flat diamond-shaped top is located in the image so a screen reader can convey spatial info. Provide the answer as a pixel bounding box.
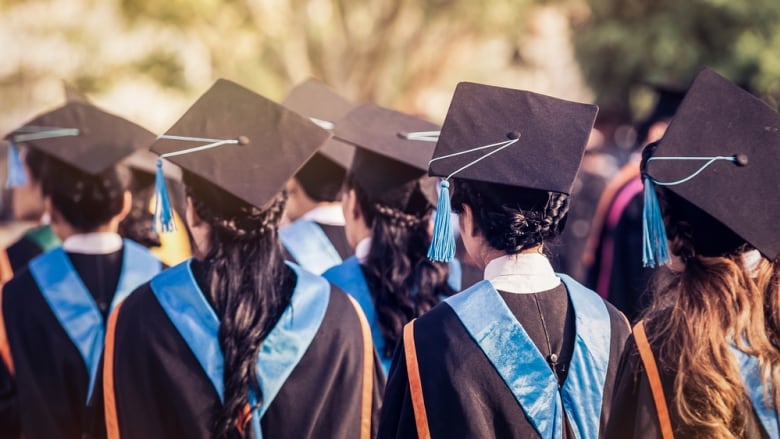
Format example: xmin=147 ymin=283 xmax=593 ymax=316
xmin=5 ymin=101 xmax=155 ymax=179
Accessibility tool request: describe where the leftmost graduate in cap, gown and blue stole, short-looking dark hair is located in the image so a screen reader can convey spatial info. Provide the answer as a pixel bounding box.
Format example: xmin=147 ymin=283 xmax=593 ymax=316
xmin=0 ymin=102 xmax=161 ymax=439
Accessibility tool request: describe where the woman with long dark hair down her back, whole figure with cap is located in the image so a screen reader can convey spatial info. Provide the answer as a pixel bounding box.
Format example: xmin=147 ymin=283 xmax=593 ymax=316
xmin=103 ymin=80 xmax=384 ymax=439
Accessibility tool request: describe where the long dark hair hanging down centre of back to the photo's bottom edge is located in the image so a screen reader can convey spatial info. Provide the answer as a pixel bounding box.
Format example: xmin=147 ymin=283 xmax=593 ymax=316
xmin=184 ymin=172 xmax=292 ymax=438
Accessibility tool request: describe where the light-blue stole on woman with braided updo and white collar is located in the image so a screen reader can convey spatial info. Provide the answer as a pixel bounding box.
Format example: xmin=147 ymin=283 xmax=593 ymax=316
xmin=446 ymin=274 xmax=611 ymax=439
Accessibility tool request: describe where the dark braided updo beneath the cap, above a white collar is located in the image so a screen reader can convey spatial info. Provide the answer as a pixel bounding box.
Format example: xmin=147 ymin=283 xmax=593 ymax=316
xmin=452 ymin=178 xmax=569 ymax=255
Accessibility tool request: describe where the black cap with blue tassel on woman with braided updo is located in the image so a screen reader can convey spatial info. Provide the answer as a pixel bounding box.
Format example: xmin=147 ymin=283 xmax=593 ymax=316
xmin=428 ymin=82 xmax=598 ymax=261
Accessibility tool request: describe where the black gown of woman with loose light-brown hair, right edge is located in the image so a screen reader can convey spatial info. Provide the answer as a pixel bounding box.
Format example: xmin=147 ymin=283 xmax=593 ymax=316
xmin=605 ymin=325 xmax=768 ymax=439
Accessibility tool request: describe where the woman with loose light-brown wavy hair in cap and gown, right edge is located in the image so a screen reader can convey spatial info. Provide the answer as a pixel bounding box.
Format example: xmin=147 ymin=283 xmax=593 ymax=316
xmin=606 ymin=68 xmax=780 ymax=439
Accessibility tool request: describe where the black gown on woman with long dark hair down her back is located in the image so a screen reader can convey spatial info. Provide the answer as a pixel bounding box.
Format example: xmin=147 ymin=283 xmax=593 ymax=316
xmin=107 ymin=261 xmax=384 ymax=439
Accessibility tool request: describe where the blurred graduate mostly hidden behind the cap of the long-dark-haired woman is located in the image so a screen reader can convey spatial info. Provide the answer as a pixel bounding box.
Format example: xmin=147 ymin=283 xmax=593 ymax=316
xmin=279 ymin=79 xmax=355 ymax=274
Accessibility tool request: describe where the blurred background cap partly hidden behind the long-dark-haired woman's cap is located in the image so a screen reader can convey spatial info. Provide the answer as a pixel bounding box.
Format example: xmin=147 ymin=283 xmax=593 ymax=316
xmin=282 ymin=79 xmax=355 ymax=201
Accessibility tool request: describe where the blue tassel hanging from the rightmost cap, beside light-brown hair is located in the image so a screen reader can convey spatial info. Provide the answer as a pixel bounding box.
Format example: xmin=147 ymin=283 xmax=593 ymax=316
xmin=642 ymin=177 xmax=671 ymax=267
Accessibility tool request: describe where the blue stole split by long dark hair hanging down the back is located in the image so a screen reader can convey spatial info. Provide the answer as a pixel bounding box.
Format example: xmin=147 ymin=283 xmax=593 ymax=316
xmin=151 ymin=260 xmax=330 ymax=439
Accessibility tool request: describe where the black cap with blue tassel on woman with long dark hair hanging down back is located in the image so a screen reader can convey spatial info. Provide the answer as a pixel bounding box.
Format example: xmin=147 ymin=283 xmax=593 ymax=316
xmin=151 ymin=79 xmax=330 ymax=231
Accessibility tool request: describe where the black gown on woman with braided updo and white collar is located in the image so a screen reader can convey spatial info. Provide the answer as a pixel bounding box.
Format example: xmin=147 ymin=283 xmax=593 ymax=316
xmin=379 ymin=285 xmax=629 ymax=439
